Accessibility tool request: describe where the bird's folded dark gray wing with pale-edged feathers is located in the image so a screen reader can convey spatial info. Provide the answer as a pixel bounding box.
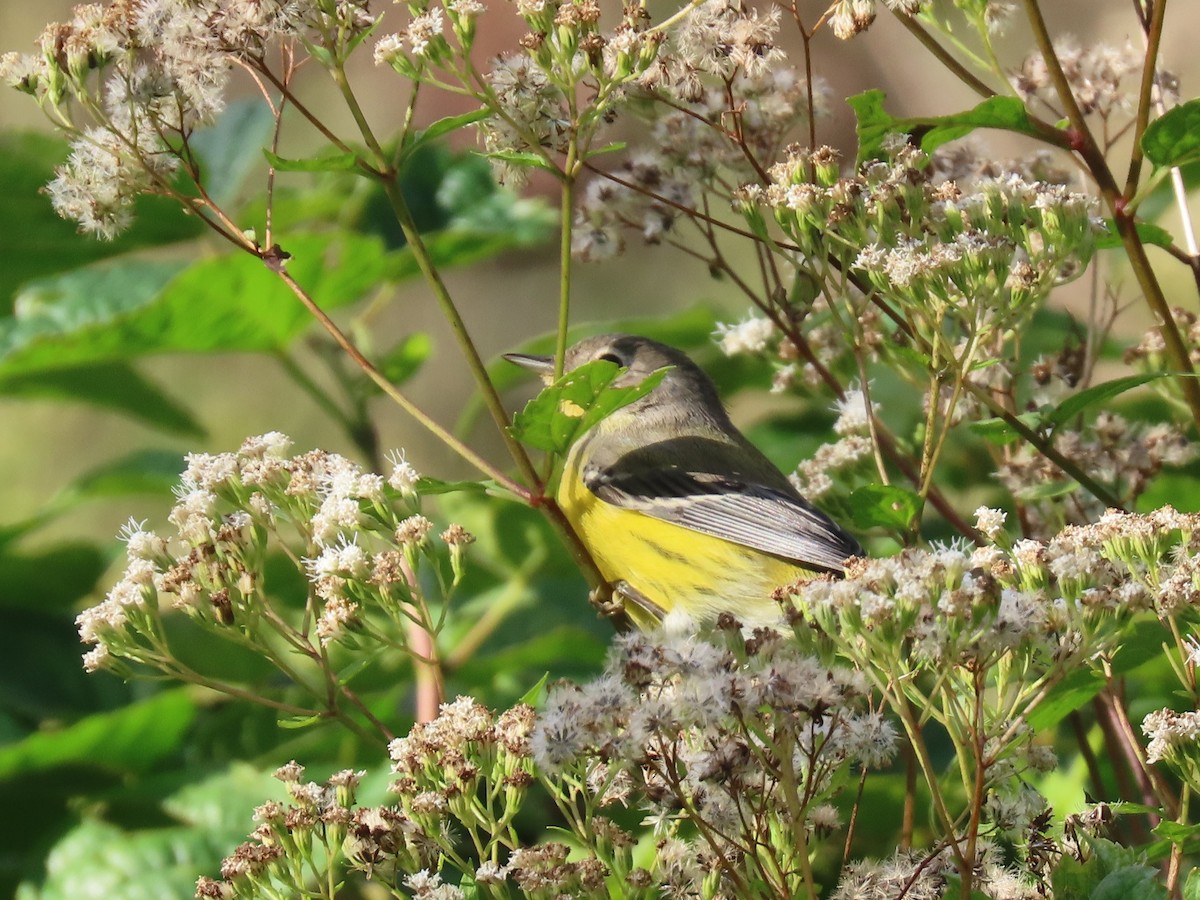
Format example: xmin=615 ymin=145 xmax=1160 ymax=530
xmin=583 ymin=467 xmax=863 ymax=572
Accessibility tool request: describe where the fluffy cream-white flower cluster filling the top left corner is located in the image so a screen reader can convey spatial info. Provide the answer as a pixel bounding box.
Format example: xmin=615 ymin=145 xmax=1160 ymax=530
xmin=0 ymin=0 xmax=372 ymax=239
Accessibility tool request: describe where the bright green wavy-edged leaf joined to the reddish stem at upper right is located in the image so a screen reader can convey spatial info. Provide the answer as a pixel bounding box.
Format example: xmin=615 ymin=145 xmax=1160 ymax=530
xmin=846 ymin=90 xmax=1039 ymax=162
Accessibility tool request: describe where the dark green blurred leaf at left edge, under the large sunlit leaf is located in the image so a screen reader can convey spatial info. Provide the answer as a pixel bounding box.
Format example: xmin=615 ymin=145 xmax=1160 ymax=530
xmin=0 ymin=362 xmax=204 ymax=438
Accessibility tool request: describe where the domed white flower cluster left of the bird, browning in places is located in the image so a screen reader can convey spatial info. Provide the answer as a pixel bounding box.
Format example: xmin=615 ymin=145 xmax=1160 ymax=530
xmin=77 ymin=432 xmax=473 ymax=671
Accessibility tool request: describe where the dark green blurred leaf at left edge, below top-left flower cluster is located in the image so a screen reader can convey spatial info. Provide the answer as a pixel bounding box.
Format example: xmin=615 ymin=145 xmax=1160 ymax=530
xmin=0 ymin=132 xmax=204 ymax=314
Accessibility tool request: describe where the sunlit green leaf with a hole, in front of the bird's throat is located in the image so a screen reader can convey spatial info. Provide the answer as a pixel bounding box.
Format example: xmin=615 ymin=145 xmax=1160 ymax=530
xmin=510 ymin=360 xmax=667 ymax=454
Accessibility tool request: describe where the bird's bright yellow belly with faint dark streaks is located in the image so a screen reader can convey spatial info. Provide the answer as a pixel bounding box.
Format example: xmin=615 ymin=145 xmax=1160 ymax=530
xmin=558 ymin=479 xmax=811 ymax=625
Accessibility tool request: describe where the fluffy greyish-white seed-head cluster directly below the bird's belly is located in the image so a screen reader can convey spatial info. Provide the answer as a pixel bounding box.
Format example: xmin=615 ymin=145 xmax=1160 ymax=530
xmin=533 ymin=618 xmax=896 ymax=894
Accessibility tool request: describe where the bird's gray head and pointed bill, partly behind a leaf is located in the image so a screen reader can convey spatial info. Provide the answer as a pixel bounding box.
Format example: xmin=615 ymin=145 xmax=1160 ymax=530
xmin=504 ymin=334 xmax=724 ymax=416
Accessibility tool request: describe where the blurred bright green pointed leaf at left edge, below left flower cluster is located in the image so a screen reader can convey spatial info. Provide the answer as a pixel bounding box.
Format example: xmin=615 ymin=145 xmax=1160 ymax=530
xmin=0 ymin=689 xmax=196 ymax=779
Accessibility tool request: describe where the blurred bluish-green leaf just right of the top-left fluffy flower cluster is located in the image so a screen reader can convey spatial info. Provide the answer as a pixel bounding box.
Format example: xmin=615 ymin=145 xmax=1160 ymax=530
xmin=188 ymin=97 xmax=275 ymax=208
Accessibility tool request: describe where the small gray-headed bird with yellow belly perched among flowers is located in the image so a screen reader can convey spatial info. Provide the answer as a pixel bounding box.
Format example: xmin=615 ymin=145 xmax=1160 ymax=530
xmin=505 ymin=334 xmax=863 ymax=628
